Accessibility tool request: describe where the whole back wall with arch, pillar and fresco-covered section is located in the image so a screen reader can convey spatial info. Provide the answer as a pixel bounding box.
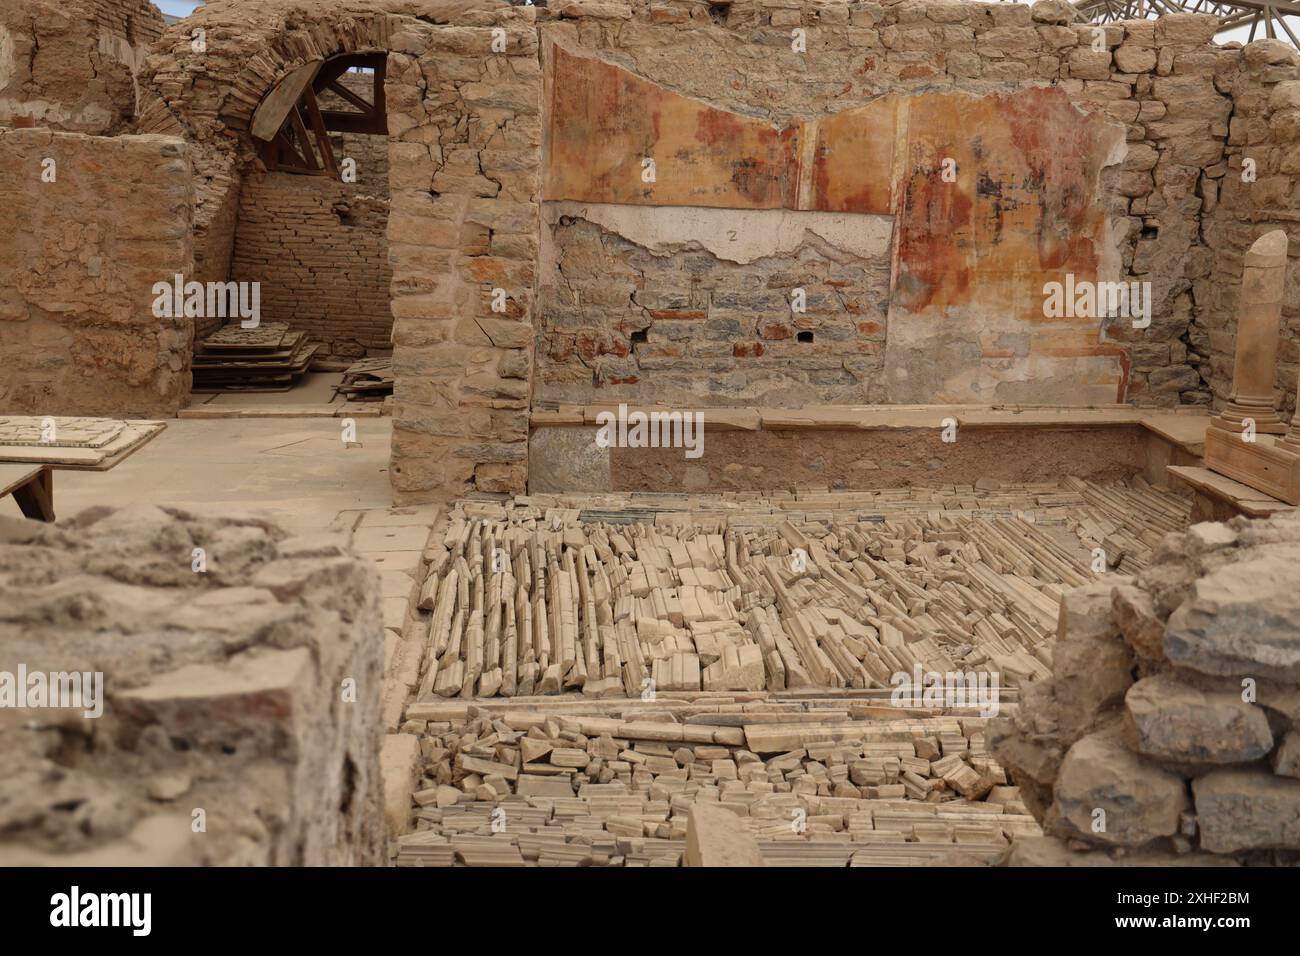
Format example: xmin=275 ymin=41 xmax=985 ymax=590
xmin=43 ymin=0 xmax=1292 ymax=497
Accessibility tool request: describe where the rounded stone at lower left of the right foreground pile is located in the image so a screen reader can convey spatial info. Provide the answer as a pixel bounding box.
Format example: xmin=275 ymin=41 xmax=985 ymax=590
xmin=1049 ymin=732 xmax=1188 ymax=847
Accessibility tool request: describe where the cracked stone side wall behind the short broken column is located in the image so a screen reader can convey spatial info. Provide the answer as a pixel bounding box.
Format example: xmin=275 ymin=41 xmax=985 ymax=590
xmin=1190 ymin=40 xmax=1300 ymax=418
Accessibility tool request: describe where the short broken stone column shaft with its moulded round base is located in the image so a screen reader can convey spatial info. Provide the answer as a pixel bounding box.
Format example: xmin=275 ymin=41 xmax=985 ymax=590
xmin=1210 ymin=229 xmax=1287 ymax=434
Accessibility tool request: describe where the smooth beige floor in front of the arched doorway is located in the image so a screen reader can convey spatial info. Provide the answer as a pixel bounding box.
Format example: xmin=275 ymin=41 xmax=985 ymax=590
xmin=0 ymin=418 xmax=393 ymax=531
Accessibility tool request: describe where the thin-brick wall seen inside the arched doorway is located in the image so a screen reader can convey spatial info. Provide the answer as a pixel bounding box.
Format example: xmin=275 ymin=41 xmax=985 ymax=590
xmin=228 ymin=134 xmax=393 ymax=358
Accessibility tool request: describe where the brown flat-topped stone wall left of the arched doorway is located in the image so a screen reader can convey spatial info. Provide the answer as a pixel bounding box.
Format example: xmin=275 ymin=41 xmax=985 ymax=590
xmin=0 ymin=129 xmax=194 ymax=418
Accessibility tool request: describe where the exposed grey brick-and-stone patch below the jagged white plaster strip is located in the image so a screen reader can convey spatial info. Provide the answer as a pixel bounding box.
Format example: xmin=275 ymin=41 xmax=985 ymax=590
xmin=540 ymin=216 xmax=889 ymax=405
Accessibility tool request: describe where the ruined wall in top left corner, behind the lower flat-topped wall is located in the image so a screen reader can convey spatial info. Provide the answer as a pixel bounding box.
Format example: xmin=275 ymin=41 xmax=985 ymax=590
xmin=0 ymin=0 xmax=163 ymax=135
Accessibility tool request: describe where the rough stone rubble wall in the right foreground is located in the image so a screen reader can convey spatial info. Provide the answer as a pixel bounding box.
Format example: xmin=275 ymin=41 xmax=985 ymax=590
xmin=989 ymin=514 xmax=1300 ymax=865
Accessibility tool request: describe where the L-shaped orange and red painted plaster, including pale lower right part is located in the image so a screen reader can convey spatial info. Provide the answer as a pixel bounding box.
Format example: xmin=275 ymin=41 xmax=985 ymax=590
xmin=545 ymin=46 xmax=1127 ymax=403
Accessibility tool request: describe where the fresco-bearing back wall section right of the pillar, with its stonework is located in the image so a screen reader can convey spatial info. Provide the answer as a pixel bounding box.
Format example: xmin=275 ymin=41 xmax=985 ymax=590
xmin=537 ymin=1 xmax=1240 ymax=405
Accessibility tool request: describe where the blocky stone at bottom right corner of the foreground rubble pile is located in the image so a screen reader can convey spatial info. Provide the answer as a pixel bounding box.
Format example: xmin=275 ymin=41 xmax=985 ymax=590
xmin=1192 ymin=769 xmax=1300 ymax=853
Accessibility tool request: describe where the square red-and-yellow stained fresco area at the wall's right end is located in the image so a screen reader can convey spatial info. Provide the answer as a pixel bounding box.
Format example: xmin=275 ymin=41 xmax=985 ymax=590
xmin=897 ymin=87 xmax=1108 ymax=323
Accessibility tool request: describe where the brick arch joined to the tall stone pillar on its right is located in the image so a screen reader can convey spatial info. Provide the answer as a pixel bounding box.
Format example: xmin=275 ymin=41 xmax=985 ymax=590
xmin=138 ymin=0 xmax=542 ymax=502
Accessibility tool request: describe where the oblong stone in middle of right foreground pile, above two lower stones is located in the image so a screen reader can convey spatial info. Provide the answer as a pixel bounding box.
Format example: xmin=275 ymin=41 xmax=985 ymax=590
xmin=1125 ymin=675 xmax=1273 ymax=763
